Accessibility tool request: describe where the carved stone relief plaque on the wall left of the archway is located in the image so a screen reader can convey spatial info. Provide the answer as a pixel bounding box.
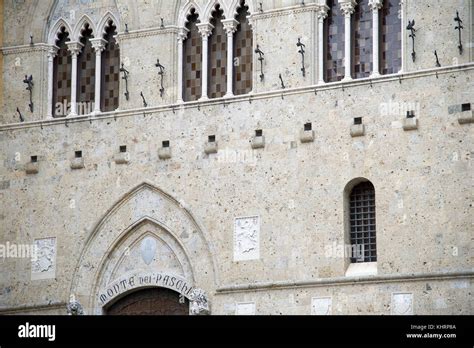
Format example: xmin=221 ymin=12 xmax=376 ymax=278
xmin=31 ymin=238 xmax=56 ymax=280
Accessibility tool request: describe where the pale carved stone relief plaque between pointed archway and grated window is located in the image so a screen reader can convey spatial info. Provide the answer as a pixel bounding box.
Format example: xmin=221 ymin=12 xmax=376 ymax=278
xmin=234 ymin=216 xmax=260 ymax=261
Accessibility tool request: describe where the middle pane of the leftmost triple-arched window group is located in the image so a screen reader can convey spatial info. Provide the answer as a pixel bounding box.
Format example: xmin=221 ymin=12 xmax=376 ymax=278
xmin=77 ymin=23 xmax=95 ymax=115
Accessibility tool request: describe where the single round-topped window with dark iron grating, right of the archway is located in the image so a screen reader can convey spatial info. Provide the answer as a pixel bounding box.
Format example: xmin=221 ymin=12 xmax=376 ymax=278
xmin=349 ymin=181 xmax=377 ymax=263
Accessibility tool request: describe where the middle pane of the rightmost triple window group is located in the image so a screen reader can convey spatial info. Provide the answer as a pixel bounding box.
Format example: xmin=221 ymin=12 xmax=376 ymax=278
xmin=351 ymin=0 xmax=373 ymax=79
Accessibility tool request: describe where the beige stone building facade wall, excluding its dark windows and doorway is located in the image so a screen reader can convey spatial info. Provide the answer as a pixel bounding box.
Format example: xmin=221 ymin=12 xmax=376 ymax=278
xmin=0 ymin=0 xmax=474 ymax=315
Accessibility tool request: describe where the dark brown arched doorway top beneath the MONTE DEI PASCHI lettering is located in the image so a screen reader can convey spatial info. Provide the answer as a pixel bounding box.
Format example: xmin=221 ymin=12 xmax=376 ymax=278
xmin=105 ymin=288 xmax=189 ymax=315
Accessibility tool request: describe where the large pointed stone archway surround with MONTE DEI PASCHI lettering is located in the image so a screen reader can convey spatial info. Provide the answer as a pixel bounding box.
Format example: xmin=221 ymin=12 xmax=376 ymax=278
xmin=71 ymin=183 xmax=217 ymax=314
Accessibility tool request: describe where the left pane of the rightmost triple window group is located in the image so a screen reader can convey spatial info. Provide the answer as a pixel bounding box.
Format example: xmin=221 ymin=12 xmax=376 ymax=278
xmin=324 ymin=0 xmax=345 ymax=82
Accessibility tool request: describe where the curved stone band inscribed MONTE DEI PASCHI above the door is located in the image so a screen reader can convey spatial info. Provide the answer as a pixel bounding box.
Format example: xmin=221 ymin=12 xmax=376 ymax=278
xmin=99 ymin=272 xmax=194 ymax=306
